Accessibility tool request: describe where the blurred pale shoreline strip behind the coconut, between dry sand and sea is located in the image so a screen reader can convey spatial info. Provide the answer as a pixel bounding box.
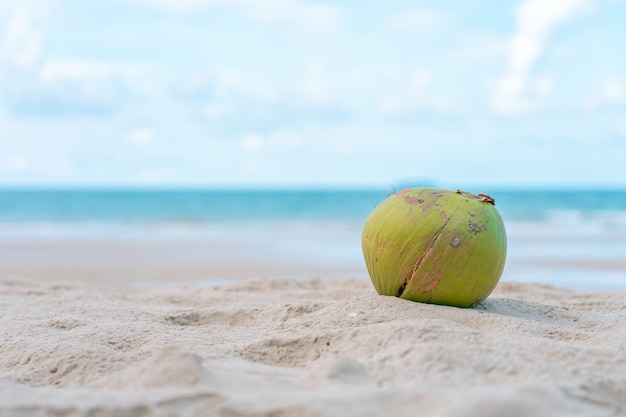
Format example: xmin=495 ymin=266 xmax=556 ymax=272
xmin=0 ymin=235 xmax=626 ymax=291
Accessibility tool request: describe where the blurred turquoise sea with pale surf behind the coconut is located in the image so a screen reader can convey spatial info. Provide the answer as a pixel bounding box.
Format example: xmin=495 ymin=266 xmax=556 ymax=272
xmin=0 ymin=188 xmax=626 ymax=290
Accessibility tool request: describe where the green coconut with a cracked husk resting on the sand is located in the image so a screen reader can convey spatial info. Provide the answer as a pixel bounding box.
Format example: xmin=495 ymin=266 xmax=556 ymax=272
xmin=362 ymin=188 xmax=506 ymax=307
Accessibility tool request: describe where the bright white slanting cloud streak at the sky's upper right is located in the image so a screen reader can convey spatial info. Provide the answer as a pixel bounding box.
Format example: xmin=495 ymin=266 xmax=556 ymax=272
xmin=492 ymin=0 xmax=588 ymax=114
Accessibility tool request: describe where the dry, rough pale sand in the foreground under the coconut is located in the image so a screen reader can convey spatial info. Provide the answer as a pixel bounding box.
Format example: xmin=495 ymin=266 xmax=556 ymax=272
xmin=0 ymin=275 xmax=626 ymax=417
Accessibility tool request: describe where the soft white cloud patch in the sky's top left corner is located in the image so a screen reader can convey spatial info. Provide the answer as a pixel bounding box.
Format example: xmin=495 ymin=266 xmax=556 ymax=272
xmin=0 ymin=4 xmax=140 ymax=115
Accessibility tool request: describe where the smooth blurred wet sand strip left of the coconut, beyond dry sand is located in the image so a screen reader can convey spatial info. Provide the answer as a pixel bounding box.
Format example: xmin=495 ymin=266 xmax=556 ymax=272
xmin=0 ymin=240 xmax=367 ymax=283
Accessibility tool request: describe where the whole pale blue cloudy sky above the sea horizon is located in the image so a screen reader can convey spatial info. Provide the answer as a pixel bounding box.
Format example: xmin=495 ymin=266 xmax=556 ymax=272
xmin=0 ymin=0 xmax=626 ymax=188
